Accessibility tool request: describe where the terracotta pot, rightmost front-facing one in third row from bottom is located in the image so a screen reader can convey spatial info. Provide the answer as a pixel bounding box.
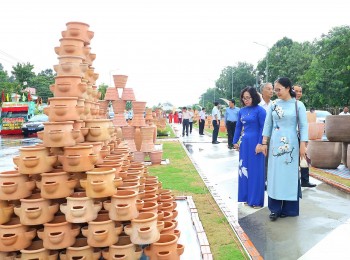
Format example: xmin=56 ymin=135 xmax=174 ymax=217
xmin=103 ymin=190 xmax=143 ymax=221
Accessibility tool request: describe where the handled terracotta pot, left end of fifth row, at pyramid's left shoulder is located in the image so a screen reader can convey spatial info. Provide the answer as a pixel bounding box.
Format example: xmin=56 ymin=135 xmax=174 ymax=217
xmin=13 ymin=146 xmax=57 ymax=174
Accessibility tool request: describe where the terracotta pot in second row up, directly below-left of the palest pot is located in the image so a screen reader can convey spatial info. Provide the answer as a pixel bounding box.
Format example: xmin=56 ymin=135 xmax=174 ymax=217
xmin=38 ymin=215 xmax=80 ymax=250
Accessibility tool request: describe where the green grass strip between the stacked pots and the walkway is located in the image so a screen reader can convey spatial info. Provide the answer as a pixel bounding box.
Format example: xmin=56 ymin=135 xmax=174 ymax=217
xmin=148 ymin=141 xmax=248 ymax=260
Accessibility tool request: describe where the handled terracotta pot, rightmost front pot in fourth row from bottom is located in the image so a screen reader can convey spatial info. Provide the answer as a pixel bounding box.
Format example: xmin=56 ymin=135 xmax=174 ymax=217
xmin=80 ymin=168 xmax=123 ymax=198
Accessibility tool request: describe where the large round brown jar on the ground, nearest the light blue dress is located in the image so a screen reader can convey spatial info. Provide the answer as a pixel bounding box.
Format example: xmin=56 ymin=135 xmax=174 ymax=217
xmin=307 ymin=140 xmax=342 ymax=169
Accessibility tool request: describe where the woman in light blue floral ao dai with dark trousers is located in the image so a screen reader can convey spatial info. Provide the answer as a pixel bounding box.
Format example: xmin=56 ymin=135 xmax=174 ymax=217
xmin=261 ymin=77 xmax=308 ymax=221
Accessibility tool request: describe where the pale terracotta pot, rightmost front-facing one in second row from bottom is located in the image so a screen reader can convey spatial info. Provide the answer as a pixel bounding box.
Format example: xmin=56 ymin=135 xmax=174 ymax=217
xmin=124 ymin=212 xmax=164 ymax=245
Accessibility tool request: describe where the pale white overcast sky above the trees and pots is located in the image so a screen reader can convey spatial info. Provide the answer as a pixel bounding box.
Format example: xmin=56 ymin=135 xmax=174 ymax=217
xmin=0 ymin=0 xmax=350 ymax=106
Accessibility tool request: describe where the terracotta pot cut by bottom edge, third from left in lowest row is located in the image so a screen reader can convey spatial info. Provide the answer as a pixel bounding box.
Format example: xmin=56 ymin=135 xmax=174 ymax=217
xmin=102 ymin=236 xmax=142 ymax=260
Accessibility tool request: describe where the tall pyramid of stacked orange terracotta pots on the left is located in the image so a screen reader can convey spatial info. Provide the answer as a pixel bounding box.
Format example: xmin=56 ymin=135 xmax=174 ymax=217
xmin=0 ymin=22 xmax=184 ymax=259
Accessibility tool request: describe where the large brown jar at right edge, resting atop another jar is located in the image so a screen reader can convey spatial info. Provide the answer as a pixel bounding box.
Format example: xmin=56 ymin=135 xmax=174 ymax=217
xmin=326 ymin=115 xmax=350 ymax=143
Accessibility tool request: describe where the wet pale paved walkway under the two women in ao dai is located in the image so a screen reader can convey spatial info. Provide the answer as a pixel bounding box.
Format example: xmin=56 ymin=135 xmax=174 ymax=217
xmin=173 ymin=125 xmax=350 ymax=260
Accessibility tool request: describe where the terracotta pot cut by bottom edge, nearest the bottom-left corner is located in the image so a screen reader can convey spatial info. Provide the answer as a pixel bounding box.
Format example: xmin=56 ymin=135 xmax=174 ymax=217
xmin=16 ymin=240 xmax=58 ymax=260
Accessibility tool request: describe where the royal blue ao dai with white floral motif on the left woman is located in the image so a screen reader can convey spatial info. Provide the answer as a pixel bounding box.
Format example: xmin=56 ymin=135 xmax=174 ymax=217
xmin=233 ymin=106 xmax=266 ymax=206
